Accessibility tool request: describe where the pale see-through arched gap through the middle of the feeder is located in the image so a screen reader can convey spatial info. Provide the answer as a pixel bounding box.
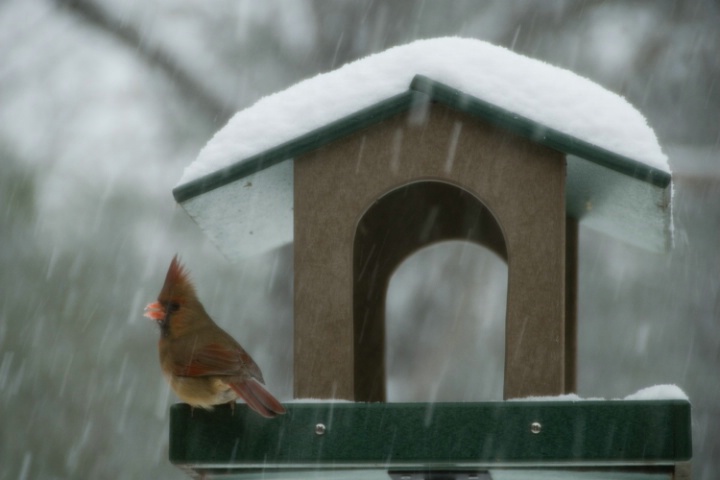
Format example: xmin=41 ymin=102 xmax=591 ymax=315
xmin=385 ymin=241 xmax=508 ymax=402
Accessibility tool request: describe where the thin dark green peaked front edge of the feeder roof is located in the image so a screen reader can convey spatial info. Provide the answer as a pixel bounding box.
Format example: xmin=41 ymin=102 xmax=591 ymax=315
xmin=173 ymin=75 xmax=671 ymax=203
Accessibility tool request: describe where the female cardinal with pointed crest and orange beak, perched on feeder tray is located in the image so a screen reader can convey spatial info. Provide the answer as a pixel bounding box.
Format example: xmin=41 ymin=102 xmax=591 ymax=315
xmin=145 ymin=255 xmax=285 ymax=417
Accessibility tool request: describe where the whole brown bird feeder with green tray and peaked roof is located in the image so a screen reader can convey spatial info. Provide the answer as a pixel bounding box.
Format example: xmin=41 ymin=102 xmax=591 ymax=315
xmin=170 ymin=39 xmax=691 ymax=480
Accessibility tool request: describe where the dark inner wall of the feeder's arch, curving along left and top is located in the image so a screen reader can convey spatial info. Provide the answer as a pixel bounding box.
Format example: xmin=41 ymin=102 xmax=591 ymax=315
xmin=353 ymin=181 xmax=507 ymax=401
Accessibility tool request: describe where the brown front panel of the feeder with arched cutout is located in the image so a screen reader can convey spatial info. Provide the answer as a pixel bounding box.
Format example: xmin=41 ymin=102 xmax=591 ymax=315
xmin=295 ymin=105 xmax=565 ymax=398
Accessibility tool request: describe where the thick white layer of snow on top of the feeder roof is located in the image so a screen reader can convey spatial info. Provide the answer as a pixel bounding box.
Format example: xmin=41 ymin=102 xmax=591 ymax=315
xmin=179 ymin=37 xmax=670 ymax=184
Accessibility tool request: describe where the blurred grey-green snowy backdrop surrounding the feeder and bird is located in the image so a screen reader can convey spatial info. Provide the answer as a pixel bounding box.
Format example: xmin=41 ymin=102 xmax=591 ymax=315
xmin=0 ymin=0 xmax=720 ymax=480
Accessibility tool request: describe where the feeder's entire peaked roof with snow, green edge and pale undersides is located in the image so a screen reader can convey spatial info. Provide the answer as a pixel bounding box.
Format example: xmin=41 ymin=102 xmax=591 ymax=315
xmin=174 ymin=38 xmax=671 ymax=257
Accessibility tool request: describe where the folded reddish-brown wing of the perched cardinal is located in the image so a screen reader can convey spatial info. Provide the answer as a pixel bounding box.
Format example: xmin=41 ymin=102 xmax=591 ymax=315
xmin=173 ymin=343 xmax=262 ymax=381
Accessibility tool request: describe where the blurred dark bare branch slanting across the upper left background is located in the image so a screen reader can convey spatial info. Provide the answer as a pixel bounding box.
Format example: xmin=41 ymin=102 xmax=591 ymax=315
xmin=51 ymin=0 xmax=235 ymax=125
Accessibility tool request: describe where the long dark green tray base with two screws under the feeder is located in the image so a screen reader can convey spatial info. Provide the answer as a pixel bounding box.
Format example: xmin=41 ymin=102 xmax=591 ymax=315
xmin=169 ymin=400 xmax=692 ymax=478
